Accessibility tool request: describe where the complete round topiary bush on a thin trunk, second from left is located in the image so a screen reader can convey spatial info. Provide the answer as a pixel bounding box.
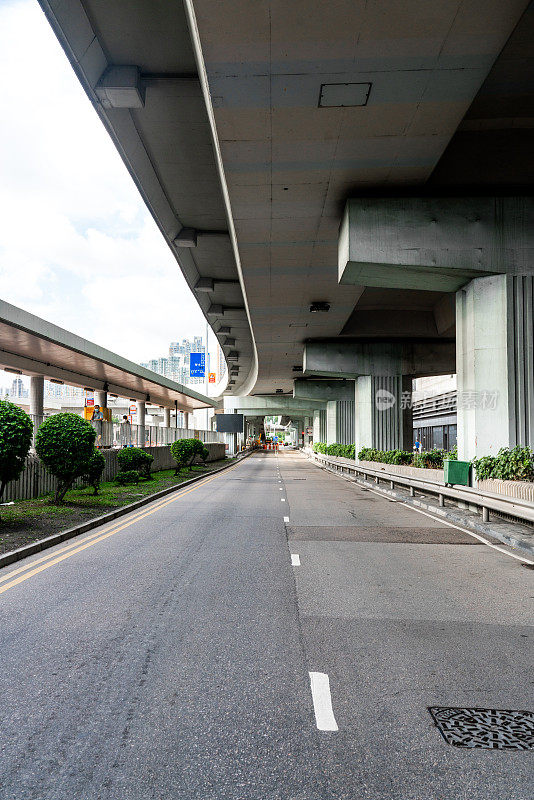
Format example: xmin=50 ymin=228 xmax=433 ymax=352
xmin=35 ymin=413 xmax=96 ymax=503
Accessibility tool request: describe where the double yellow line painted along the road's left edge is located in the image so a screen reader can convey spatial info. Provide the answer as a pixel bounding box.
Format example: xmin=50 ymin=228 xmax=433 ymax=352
xmin=0 ymin=464 xmax=245 ymax=594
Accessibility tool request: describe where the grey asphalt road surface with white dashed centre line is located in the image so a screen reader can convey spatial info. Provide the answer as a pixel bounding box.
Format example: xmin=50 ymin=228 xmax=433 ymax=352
xmin=0 ymin=452 xmax=534 ymax=800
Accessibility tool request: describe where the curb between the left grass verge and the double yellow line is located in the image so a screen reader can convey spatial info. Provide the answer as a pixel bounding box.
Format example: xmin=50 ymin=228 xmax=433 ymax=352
xmin=0 ymin=450 xmax=253 ymax=569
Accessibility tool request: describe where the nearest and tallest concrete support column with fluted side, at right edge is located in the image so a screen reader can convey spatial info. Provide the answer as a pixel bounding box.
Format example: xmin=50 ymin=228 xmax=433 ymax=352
xmin=456 ymin=275 xmax=534 ymax=461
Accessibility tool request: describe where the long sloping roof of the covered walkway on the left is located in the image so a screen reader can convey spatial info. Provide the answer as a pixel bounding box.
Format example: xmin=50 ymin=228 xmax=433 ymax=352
xmin=0 ymin=301 xmax=218 ymax=414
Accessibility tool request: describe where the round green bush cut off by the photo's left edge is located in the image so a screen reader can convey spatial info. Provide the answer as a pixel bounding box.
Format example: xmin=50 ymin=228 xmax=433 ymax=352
xmin=0 ymin=400 xmax=33 ymax=500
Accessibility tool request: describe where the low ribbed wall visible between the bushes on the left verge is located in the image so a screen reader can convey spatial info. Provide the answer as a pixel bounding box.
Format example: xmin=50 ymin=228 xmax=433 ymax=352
xmin=2 ymin=442 xmax=225 ymax=503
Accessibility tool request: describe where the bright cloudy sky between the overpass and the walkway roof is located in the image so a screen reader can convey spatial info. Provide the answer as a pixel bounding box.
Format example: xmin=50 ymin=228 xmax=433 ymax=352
xmin=0 ymin=0 xmax=212 ymax=383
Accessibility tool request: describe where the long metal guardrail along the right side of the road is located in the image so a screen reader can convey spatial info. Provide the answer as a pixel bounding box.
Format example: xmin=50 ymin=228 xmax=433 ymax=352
xmin=310 ymin=453 xmax=534 ymax=524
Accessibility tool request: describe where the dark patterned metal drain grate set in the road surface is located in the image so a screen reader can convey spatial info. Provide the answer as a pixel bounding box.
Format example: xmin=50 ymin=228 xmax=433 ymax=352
xmin=428 ymin=707 xmax=534 ymax=750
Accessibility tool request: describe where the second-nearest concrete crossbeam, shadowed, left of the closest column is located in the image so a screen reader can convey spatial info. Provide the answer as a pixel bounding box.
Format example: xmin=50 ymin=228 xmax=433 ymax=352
xmin=303 ymin=341 xmax=456 ymax=378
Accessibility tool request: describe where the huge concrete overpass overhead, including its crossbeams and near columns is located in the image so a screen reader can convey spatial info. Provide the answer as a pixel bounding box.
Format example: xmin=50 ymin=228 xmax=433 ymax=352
xmin=41 ymin=0 xmax=534 ymax=457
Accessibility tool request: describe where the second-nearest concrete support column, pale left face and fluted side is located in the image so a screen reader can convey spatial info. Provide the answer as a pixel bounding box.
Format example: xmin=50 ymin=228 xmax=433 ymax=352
xmin=354 ymin=375 xmax=413 ymax=456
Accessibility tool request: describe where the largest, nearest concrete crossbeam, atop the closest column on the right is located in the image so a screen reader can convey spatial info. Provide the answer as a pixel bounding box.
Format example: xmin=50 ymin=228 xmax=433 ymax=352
xmin=338 ymin=197 xmax=534 ymax=292
